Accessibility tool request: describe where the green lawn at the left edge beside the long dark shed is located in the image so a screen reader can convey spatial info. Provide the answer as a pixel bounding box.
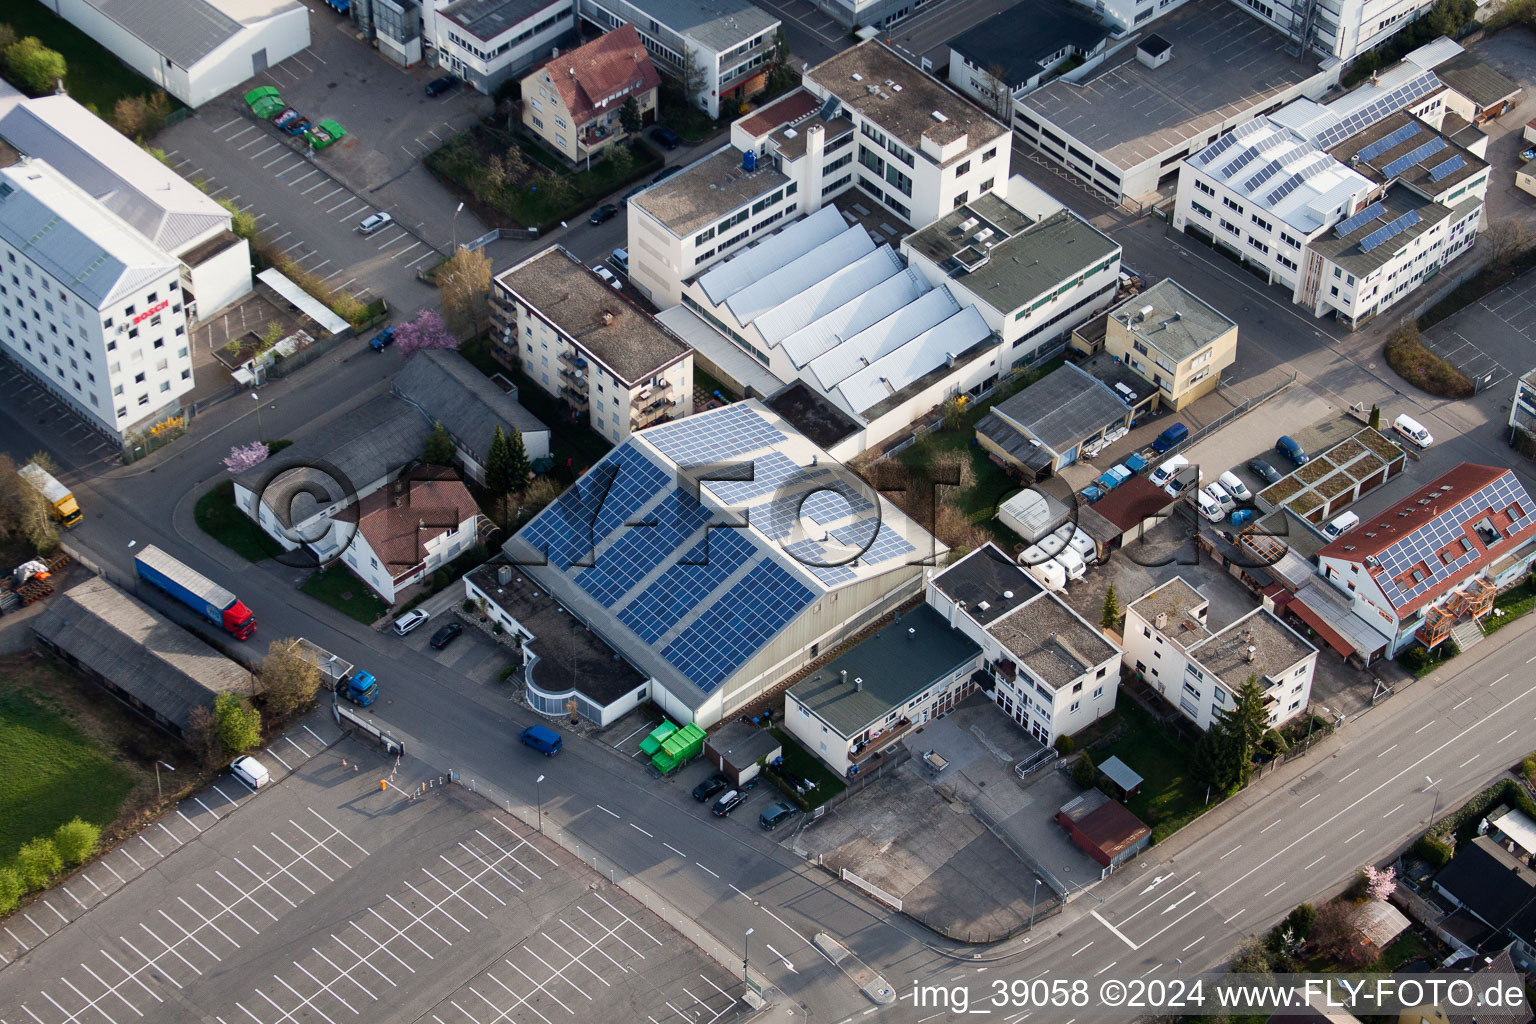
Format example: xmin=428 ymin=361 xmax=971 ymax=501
xmin=0 ymin=662 xmax=135 ymax=864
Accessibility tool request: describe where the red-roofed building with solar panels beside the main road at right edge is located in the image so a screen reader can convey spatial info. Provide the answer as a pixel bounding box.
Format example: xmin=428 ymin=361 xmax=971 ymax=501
xmin=1318 ymin=462 xmax=1536 ymax=657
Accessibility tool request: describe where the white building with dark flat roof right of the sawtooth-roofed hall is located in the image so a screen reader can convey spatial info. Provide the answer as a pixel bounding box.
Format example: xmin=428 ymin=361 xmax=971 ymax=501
xmin=902 ymin=192 xmax=1120 ymax=370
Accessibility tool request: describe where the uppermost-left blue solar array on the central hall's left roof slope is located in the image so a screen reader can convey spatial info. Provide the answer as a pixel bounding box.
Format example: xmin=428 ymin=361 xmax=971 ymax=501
xmin=519 ymin=444 xmax=668 ymax=571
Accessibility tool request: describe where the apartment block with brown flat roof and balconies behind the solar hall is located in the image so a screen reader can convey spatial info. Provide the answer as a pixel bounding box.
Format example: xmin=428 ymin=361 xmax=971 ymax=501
xmin=492 ymin=246 xmax=693 ymax=444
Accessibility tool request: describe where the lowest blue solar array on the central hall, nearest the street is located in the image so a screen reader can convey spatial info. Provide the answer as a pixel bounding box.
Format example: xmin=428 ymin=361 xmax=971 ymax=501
xmin=662 ymin=562 xmax=814 ymax=692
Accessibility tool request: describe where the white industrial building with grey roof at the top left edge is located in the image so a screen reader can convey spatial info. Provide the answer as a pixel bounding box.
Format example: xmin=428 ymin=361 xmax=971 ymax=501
xmin=48 ymin=0 xmax=309 ymax=107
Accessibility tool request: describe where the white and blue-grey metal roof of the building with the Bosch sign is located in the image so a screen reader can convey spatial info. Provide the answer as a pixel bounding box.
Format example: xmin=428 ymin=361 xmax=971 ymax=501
xmin=0 ymin=160 xmax=177 ymax=309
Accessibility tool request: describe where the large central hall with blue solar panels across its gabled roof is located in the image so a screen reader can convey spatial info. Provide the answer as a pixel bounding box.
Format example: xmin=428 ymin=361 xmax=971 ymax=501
xmin=497 ymin=399 xmax=943 ymax=728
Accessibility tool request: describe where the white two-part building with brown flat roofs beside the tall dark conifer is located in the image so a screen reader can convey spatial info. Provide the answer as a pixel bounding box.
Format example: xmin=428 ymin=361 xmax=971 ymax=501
xmin=1124 ymin=577 xmax=1318 ymax=729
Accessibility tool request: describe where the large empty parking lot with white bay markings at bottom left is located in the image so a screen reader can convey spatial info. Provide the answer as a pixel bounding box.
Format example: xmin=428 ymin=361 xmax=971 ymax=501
xmin=0 ymin=721 xmax=739 ymax=1024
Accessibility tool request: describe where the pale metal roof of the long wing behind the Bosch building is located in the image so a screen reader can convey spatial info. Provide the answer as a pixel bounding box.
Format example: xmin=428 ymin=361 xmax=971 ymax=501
xmin=0 ymin=95 xmax=229 ymax=253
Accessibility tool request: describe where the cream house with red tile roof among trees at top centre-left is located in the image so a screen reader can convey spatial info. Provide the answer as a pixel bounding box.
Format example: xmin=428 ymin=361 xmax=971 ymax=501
xmin=522 ymin=25 xmax=660 ymax=163
